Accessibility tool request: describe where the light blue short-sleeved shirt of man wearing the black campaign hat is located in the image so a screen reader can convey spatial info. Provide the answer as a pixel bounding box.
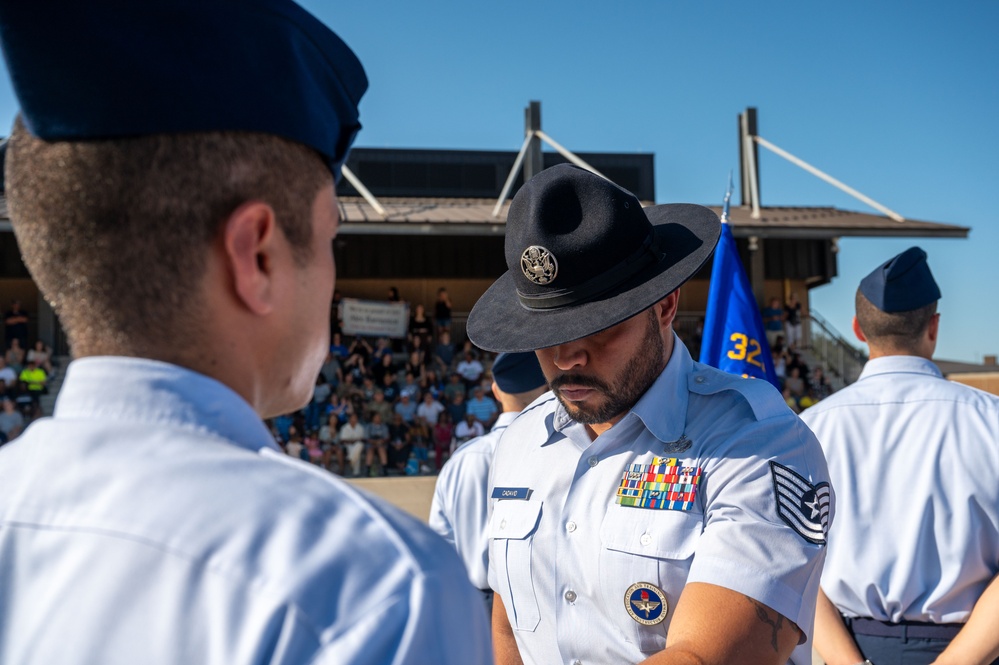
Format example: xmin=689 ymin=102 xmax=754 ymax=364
xmin=488 ymin=337 xmax=832 ymax=665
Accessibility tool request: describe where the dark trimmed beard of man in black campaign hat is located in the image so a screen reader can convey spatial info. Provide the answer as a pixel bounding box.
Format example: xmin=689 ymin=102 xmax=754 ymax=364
xmin=549 ymin=311 xmax=666 ymax=425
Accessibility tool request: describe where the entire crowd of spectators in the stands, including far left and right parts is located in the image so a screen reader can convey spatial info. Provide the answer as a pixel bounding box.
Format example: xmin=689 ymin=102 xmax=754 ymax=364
xmin=0 ymin=289 xmax=832 ymax=454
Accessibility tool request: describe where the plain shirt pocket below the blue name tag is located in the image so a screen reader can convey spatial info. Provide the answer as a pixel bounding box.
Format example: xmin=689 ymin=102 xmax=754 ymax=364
xmin=489 ymin=500 xmax=542 ymax=632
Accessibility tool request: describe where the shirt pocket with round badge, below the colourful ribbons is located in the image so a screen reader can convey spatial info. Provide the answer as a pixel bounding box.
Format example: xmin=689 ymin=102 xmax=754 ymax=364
xmin=599 ymin=504 xmax=703 ymax=653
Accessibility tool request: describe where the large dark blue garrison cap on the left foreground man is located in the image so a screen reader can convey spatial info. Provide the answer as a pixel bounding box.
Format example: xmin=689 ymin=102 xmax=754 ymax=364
xmin=0 ymin=0 xmax=368 ymax=177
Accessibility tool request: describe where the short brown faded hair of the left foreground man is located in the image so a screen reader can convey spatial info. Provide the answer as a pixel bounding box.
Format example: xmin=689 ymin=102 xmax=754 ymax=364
xmin=6 ymin=118 xmax=332 ymax=355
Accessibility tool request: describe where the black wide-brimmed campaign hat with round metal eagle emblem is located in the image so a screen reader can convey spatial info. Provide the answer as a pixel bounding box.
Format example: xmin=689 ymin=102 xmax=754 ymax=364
xmin=467 ymin=164 xmax=721 ymax=352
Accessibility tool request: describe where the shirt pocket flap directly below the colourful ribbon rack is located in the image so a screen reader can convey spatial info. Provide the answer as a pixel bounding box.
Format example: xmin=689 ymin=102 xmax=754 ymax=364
xmin=600 ymin=505 xmax=704 ymax=559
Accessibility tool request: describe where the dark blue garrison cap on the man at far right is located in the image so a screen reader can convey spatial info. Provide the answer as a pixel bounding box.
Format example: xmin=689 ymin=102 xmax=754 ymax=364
xmin=860 ymin=247 xmax=940 ymax=313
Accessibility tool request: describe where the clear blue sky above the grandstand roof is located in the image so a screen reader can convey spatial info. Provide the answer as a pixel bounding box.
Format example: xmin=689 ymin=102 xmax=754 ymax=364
xmin=0 ymin=0 xmax=999 ymax=361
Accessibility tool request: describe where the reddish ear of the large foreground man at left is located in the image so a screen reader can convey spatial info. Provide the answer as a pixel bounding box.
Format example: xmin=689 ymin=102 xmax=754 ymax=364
xmin=222 ymin=201 xmax=279 ymax=314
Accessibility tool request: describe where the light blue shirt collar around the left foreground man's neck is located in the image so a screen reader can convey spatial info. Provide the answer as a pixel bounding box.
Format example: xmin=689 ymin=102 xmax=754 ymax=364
xmin=53 ymin=356 xmax=278 ymax=451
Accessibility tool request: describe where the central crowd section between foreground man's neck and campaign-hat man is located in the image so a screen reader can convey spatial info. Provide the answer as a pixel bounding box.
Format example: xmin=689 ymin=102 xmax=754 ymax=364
xmin=268 ymin=288 xmax=499 ymax=476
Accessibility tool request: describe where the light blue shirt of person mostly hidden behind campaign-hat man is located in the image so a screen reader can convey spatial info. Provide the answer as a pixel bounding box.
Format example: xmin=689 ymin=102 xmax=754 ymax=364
xmin=430 ymin=412 xmax=519 ymax=590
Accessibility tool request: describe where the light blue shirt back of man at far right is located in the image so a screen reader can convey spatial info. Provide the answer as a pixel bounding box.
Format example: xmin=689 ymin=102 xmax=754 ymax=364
xmin=802 ymin=356 xmax=999 ymax=623
